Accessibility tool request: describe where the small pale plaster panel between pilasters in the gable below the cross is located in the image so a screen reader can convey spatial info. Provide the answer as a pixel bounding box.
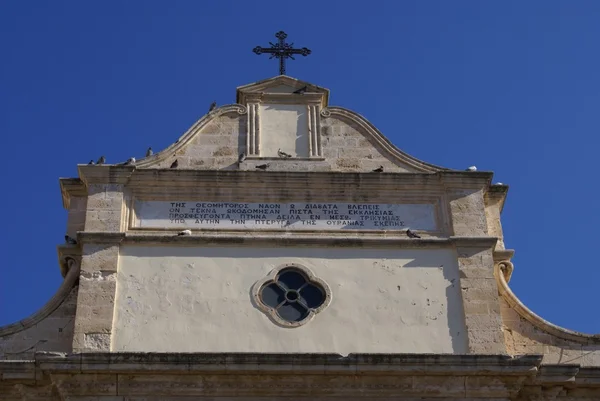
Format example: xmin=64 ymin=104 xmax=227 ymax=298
xmin=259 ymin=104 xmax=309 ymax=157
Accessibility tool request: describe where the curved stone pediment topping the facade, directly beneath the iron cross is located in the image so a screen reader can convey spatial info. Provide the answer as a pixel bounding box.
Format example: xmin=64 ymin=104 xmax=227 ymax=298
xmin=136 ymin=76 xmax=446 ymax=173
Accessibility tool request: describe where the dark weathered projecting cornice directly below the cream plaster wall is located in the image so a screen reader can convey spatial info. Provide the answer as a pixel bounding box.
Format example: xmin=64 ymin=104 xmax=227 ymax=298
xmin=35 ymin=352 xmax=542 ymax=376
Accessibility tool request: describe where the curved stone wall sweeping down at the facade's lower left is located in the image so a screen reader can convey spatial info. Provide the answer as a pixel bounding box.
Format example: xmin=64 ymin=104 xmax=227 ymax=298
xmin=0 ymin=287 xmax=78 ymax=360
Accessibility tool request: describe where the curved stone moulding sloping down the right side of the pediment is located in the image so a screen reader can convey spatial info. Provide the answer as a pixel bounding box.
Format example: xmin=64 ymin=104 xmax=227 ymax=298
xmin=321 ymin=106 xmax=448 ymax=173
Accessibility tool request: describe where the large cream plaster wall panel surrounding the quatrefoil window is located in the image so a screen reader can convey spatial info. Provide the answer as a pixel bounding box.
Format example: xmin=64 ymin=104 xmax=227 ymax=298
xmin=111 ymin=246 xmax=467 ymax=354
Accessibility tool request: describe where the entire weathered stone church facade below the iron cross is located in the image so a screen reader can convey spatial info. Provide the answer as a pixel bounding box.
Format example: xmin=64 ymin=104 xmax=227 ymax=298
xmin=0 ymin=75 xmax=600 ymax=401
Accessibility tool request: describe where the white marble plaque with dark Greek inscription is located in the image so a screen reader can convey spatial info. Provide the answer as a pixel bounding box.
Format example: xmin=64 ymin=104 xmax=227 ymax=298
xmin=133 ymin=200 xmax=436 ymax=231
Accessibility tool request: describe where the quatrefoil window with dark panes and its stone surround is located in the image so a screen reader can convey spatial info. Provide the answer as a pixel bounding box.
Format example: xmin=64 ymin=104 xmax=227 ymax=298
xmin=252 ymin=264 xmax=331 ymax=327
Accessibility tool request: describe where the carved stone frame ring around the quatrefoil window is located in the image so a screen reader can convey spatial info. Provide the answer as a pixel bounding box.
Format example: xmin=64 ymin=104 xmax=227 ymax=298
xmin=252 ymin=263 xmax=331 ymax=328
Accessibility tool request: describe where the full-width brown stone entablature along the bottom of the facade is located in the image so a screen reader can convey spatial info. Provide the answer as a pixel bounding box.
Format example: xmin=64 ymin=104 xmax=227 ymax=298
xmin=7 ymin=353 xmax=600 ymax=401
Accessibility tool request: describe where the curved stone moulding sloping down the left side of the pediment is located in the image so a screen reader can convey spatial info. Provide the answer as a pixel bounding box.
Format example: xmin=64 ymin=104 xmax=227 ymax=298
xmin=135 ymin=104 xmax=248 ymax=169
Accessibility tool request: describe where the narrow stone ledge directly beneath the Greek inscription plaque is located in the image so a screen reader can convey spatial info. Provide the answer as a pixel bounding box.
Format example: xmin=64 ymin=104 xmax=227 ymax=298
xmin=123 ymin=231 xmax=451 ymax=248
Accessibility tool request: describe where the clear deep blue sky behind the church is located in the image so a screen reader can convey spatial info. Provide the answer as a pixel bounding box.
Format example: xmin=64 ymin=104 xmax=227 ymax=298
xmin=0 ymin=0 xmax=600 ymax=332
